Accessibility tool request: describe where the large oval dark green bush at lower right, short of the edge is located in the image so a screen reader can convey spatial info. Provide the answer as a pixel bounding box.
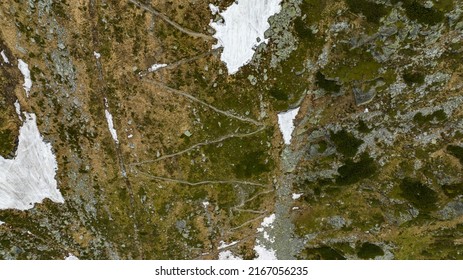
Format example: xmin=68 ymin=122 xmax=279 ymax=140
xmin=399 ymin=178 xmax=437 ymax=213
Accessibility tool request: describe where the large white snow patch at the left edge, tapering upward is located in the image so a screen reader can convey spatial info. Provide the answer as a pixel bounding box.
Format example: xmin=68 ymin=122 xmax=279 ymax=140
xmin=0 ymin=113 xmax=64 ymax=210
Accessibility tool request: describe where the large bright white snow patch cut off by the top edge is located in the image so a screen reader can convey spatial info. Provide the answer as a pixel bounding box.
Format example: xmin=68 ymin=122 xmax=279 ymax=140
xmin=209 ymin=0 xmax=281 ymax=75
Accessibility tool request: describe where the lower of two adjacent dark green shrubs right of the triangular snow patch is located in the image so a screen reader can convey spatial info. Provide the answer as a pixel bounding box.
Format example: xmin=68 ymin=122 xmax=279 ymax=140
xmin=336 ymin=153 xmax=377 ymax=185
